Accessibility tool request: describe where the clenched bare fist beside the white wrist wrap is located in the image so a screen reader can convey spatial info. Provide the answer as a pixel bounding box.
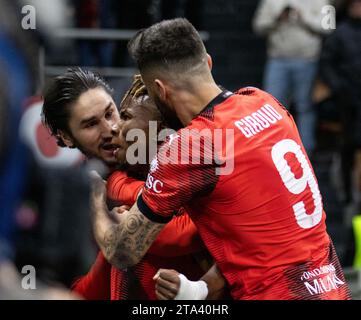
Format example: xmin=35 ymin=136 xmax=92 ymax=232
xmin=153 ymin=269 xmax=180 ymax=300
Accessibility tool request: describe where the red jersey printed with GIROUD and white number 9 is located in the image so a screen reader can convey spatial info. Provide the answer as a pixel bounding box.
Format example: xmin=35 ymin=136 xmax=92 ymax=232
xmin=137 ymin=87 xmax=350 ymax=299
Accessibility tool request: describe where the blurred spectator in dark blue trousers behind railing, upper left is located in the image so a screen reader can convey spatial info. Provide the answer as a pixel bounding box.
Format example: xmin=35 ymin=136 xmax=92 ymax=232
xmin=75 ymin=0 xmax=116 ymax=67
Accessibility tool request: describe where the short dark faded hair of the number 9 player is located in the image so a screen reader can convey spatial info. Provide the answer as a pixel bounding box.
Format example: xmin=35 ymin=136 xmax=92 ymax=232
xmin=128 ymin=18 xmax=206 ymax=72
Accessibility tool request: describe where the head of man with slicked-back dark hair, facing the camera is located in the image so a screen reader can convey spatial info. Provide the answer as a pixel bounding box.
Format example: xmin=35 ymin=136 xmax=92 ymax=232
xmin=43 ymin=68 xmax=120 ymax=169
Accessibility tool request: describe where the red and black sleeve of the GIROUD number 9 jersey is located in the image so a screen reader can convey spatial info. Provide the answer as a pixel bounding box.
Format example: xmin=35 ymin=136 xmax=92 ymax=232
xmin=137 ymin=128 xmax=219 ymax=223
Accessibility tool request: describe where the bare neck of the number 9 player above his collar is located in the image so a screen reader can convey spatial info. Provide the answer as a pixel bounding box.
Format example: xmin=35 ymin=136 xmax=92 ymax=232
xmin=172 ymin=82 xmax=222 ymax=126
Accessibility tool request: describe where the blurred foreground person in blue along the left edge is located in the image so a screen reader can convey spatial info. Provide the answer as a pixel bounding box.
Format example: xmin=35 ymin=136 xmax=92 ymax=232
xmin=0 ymin=0 xmax=85 ymax=299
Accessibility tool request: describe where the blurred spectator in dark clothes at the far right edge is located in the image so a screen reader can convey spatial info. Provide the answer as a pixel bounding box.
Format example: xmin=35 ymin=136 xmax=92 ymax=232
xmin=320 ymin=0 xmax=361 ymax=203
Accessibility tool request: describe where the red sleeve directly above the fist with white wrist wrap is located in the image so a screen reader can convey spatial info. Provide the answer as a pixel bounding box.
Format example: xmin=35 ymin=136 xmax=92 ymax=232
xmin=148 ymin=213 xmax=205 ymax=257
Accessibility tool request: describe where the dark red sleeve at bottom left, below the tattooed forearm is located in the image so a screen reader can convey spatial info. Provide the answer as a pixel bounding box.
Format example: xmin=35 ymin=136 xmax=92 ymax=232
xmin=72 ymin=252 xmax=111 ymax=300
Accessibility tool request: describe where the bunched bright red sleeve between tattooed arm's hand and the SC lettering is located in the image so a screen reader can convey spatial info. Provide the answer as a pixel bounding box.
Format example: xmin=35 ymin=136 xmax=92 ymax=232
xmin=107 ymin=171 xmax=144 ymax=206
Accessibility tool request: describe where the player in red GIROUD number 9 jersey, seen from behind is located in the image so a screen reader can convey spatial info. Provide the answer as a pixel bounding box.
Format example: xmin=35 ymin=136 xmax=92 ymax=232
xmin=88 ymin=18 xmax=350 ymax=300
